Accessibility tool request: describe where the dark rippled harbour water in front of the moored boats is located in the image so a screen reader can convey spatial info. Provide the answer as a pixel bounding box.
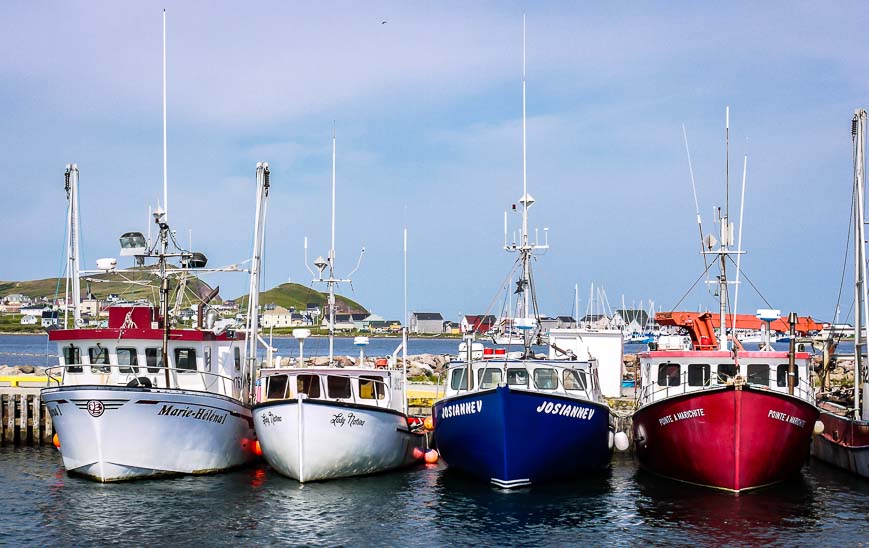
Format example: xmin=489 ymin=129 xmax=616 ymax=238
xmin=0 ymin=447 xmax=869 ymax=546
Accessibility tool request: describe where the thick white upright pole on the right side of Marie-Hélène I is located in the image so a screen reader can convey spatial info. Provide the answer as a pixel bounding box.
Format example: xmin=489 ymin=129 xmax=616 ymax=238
xmin=245 ymin=162 xmax=271 ymax=398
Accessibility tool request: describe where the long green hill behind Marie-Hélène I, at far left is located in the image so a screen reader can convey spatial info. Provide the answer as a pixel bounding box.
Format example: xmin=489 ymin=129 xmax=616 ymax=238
xmin=0 ymin=269 xmax=219 ymax=305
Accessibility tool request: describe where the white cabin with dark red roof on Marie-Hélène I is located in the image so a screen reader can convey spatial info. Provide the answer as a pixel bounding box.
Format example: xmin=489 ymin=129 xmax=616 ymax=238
xmin=47 ymin=305 xmax=244 ymax=399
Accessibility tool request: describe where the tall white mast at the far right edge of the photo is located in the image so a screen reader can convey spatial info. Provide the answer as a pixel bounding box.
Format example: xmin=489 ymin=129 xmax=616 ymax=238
xmin=851 ymin=109 xmax=869 ymax=419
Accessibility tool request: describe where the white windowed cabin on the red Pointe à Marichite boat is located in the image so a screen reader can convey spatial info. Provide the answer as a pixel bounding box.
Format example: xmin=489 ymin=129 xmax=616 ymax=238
xmin=638 ymin=350 xmax=814 ymax=404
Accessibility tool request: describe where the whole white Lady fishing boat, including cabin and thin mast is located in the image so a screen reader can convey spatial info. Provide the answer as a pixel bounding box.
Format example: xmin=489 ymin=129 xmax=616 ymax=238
xmin=253 ymin=133 xmax=427 ymax=483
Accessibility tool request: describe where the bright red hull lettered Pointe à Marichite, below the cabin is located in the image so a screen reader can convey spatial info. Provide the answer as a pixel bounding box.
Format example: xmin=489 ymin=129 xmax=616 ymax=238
xmin=634 ymin=386 xmax=818 ymax=492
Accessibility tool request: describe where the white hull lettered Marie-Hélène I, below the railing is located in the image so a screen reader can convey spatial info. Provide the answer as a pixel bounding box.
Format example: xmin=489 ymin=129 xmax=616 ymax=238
xmin=42 ymin=386 xmax=255 ymax=482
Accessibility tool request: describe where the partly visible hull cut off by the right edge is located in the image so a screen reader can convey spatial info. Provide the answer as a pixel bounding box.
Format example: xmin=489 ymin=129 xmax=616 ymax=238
xmin=812 ymin=408 xmax=869 ymax=478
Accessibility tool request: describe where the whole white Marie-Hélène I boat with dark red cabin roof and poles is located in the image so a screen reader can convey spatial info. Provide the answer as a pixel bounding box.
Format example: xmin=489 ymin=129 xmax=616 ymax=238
xmin=42 ymin=164 xmax=269 ymax=482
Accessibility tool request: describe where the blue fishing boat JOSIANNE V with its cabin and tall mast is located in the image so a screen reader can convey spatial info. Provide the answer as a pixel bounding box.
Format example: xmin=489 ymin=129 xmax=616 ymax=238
xmin=432 ymin=16 xmax=628 ymax=489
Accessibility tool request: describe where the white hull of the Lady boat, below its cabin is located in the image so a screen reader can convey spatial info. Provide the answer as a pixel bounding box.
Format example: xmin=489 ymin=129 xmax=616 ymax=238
xmin=253 ymin=399 xmax=426 ymax=483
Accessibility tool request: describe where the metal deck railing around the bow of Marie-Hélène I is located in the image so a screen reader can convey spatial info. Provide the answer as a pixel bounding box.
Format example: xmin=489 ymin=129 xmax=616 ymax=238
xmin=45 ymin=364 xmax=241 ymax=399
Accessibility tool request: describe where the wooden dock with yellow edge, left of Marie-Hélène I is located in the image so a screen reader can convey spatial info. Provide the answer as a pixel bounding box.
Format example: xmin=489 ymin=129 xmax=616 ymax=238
xmin=0 ymin=375 xmax=54 ymax=445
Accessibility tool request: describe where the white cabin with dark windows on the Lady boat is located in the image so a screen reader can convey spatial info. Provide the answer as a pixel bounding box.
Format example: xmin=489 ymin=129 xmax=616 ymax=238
xmin=257 ymin=367 xmax=404 ymax=411
